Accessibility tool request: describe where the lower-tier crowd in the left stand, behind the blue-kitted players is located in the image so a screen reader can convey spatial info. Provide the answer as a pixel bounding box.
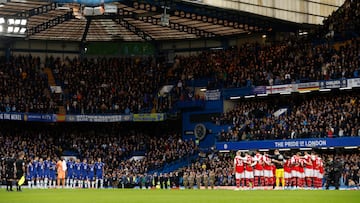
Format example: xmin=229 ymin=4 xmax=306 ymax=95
xmin=0 ymin=124 xmax=197 ymax=182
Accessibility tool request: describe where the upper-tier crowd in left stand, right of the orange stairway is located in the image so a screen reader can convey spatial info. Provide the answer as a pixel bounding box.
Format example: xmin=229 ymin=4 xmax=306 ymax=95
xmin=45 ymin=57 xmax=169 ymax=114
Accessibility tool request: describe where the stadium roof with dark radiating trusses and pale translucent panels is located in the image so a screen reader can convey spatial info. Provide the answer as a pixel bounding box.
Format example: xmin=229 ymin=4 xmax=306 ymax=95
xmin=0 ymin=0 xmax=344 ymax=42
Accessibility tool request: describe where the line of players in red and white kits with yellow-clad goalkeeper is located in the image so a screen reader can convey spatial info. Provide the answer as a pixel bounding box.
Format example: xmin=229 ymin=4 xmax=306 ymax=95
xmin=234 ymin=150 xmax=324 ymax=190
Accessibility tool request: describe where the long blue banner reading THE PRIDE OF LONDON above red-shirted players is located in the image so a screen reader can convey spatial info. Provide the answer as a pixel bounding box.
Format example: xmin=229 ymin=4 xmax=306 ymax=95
xmin=216 ymin=137 xmax=360 ymax=150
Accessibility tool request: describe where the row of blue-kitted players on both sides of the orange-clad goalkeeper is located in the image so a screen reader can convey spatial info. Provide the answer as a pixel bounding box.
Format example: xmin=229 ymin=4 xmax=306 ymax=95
xmin=26 ymin=157 xmax=105 ymax=189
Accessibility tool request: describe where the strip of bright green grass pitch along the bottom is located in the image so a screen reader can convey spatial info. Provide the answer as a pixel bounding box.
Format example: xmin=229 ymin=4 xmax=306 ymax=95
xmin=0 ymin=189 xmax=360 ymax=203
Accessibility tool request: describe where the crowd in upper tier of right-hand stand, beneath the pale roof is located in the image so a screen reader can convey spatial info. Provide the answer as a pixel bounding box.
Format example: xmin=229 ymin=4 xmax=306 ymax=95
xmin=171 ymin=38 xmax=360 ymax=88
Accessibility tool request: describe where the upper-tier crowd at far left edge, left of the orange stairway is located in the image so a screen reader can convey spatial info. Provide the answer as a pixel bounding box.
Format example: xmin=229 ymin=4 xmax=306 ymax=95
xmin=0 ymin=55 xmax=57 ymax=113
